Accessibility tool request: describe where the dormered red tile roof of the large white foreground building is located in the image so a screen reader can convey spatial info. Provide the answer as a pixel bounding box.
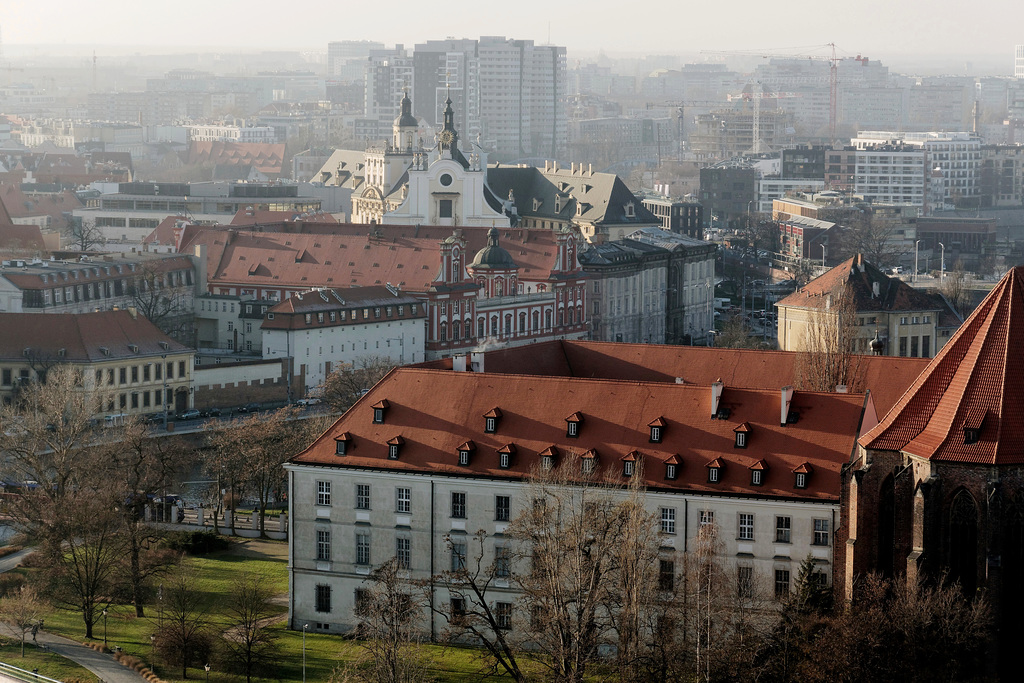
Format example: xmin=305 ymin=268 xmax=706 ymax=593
xmin=292 ymin=368 xmax=865 ymax=501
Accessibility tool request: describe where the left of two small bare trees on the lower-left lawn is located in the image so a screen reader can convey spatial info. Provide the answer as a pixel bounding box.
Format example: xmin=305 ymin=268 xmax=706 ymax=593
xmin=155 ymin=562 xmax=210 ymax=678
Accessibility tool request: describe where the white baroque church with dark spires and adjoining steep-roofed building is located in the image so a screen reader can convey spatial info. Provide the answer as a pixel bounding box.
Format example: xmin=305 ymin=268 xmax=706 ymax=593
xmin=314 ymin=92 xmax=662 ymax=243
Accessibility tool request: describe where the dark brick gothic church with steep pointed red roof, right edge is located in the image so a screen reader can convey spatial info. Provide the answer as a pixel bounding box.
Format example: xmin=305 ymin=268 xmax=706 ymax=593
xmin=835 ymin=267 xmax=1024 ymax=679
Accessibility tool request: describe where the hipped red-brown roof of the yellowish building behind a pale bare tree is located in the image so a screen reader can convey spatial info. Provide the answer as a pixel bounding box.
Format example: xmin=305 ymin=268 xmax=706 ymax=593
xmin=777 ymin=254 xmax=948 ymax=312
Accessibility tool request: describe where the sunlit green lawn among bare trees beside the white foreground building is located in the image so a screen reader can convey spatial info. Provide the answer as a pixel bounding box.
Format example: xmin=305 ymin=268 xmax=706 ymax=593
xmin=32 ymin=541 xmax=528 ymax=683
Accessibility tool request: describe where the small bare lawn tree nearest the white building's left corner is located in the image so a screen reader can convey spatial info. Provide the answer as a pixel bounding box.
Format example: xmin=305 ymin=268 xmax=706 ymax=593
xmin=222 ymin=571 xmax=279 ymax=683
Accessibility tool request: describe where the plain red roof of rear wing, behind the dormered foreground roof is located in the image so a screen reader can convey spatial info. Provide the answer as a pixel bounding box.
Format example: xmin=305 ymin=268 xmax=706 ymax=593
xmin=421 ymin=341 xmax=928 ymax=415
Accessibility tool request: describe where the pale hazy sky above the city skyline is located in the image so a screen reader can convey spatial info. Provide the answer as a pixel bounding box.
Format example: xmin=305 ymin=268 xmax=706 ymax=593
xmin=0 ymin=0 xmax=1024 ymax=64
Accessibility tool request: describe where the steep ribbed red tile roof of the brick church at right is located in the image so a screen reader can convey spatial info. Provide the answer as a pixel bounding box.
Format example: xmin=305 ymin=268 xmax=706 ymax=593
xmin=860 ymin=266 xmax=1024 ymax=465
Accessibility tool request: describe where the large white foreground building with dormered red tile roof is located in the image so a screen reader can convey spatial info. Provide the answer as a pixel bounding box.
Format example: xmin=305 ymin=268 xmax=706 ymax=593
xmin=286 ymin=358 xmax=874 ymax=633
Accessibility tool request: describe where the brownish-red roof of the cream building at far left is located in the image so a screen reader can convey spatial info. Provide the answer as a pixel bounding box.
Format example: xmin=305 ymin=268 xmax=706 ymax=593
xmin=0 ymin=310 xmax=186 ymax=362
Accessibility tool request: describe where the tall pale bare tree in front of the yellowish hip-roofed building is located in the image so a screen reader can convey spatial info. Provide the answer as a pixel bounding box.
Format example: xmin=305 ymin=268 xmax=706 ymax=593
xmin=797 ymin=285 xmax=863 ymax=391
